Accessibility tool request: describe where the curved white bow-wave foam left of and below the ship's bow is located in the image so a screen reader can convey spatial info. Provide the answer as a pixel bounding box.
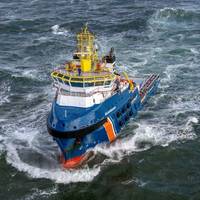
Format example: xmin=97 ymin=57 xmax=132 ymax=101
xmin=0 ymin=117 xmax=100 ymax=183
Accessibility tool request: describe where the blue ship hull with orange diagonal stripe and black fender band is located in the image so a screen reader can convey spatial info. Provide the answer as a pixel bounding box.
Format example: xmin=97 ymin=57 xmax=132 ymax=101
xmin=47 ymin=75 xmax=159 ymax=168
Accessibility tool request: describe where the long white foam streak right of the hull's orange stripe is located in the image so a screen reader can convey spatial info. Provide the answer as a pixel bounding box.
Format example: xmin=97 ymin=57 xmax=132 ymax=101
xmin=94 ymin=112 xmax=198 ymax=163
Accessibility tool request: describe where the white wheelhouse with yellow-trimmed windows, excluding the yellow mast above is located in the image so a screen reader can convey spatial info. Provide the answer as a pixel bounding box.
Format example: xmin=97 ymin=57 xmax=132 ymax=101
xmin=51 ymin=69 xmax=122 ymax=108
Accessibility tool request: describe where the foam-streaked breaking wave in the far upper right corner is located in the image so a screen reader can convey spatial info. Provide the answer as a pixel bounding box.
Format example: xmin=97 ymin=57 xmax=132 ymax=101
xmin=147 ymin=7 xmax=200 ymax=35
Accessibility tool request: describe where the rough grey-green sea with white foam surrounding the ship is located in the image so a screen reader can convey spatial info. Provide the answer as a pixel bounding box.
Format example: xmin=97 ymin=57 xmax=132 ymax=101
xmin=0 ymin=0 xmax=200 ymax=200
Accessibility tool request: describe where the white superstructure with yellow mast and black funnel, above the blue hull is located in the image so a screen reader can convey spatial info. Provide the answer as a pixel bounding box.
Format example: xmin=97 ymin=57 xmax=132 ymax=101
xmin=48 ymin=25 xmax=128 ymax=108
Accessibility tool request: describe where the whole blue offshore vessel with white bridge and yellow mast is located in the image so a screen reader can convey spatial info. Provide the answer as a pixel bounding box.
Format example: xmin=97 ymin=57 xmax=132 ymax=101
xmin=47 ymin=25 xmax=159 ymax=169
